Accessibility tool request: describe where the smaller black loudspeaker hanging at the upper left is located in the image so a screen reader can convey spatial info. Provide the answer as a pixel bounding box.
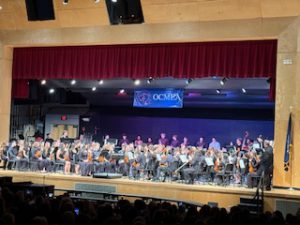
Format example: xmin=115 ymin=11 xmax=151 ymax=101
xmin=25 ymin=0 xmax=55 ymax=21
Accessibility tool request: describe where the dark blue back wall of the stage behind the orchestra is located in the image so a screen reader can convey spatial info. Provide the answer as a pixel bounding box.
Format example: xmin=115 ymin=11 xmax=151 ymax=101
xmin=82 ymin=114 xmax=274 ymax=146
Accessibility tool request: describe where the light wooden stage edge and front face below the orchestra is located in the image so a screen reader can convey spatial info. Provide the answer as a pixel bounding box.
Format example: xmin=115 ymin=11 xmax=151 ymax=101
xmin=0 ymin=170 xmax=300 ymax=211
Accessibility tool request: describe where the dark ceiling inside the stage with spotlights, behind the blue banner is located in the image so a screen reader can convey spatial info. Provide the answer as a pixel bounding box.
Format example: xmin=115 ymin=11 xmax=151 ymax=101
xmin=43 ymin=77 xmax=274 ymax=108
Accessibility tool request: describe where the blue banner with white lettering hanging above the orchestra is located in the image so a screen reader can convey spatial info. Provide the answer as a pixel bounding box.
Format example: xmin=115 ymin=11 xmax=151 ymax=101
xmin=133 ymin=89 xmax=183 ymax=108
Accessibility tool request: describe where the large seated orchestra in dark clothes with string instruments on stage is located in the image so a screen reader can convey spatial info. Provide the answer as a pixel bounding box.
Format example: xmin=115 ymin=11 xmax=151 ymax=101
xmin=0 ymin=131 xmax=273 ymax=189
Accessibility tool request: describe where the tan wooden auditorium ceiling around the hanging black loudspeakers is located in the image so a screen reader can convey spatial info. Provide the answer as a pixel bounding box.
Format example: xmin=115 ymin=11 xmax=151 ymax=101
xmin=0 ymin=0 xmax=300 ymax=30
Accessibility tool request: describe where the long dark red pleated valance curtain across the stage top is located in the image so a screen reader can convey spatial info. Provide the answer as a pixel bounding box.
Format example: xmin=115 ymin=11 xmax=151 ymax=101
xmin=13 ymin=40 xmax=277 ymax=99
